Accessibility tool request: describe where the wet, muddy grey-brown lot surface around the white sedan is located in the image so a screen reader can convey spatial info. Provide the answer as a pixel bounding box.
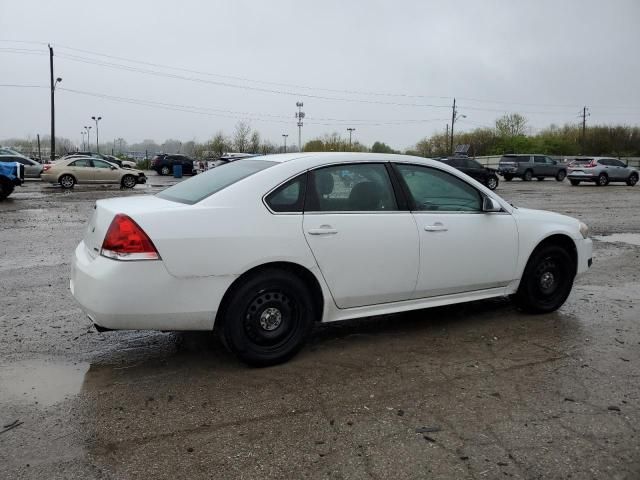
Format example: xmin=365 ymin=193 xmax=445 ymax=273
xmin=0 ymin=174 xmax=640 ymax=479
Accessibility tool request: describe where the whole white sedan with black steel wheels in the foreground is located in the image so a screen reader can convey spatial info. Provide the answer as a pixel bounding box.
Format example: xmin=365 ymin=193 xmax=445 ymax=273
xmin=70 ymin=153 xmax=592 ymax=365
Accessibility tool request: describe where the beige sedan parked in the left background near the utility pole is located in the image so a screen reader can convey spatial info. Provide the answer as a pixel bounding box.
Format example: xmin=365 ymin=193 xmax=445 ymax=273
xmin=41 ymin=157 xmax=147 ymax=188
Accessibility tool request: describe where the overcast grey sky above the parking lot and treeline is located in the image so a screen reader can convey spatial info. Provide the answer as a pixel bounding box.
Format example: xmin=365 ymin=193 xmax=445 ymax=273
xmin=0 ymin=0 xmax=640 ymax=149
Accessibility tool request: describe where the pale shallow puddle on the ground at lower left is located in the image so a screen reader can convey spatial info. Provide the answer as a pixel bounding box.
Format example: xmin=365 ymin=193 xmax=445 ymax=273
xmin=0 ymin=360 xmax=89 ymax=407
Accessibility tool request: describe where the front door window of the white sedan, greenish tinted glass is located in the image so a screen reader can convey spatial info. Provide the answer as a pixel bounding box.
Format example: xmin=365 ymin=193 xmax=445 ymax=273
xmin=396 ymin=164 xmax=482 ymax=212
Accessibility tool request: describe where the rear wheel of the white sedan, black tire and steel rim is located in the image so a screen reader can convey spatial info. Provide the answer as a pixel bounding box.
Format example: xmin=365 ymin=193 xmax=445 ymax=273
xmin=222 ymin=269 xmax=315 ymax=367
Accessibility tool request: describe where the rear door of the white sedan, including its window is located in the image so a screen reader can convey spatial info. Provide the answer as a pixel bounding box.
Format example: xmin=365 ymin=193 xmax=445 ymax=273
xmin=303 ymin=163 xmax=419 ymax=308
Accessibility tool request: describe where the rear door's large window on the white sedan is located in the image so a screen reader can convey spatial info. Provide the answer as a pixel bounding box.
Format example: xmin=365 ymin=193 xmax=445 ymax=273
xmin=304 ymin=163 xmax=398 ymax=212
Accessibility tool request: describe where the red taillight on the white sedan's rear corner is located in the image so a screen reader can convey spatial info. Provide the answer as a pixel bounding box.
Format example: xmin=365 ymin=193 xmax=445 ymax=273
xmin=100 ymin=213 xmax=160 ymax=260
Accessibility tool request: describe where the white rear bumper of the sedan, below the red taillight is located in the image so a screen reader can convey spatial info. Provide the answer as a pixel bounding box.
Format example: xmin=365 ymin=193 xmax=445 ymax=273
xmin=69 ymin=241 xmax=234 ymax=330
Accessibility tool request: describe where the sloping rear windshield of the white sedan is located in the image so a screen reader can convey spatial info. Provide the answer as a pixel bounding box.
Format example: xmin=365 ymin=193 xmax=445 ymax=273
xmin=158 ymin=160 xmax=276 ymax=205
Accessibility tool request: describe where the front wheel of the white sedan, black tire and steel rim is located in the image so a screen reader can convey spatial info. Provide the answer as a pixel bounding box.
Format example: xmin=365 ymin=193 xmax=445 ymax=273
xmin=514 ymin=244 xmax=576 ymax=313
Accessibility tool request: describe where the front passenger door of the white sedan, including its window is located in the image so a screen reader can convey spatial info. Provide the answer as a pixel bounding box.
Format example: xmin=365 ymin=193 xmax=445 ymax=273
xmin=395 ymin=163 xmax=518 ymax=298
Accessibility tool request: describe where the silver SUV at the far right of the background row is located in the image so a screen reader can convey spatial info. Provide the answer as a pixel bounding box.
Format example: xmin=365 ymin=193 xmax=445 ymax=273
xmin=567 ymin=157 xmax=638 ymax=187
